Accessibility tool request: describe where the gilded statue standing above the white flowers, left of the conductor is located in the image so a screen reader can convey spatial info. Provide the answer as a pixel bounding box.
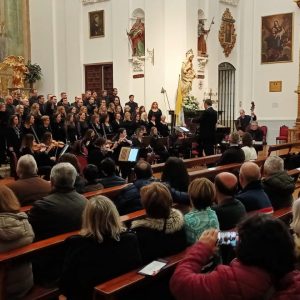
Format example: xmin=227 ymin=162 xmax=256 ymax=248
xmin=181 ymin=49 xmax=196 ymax=98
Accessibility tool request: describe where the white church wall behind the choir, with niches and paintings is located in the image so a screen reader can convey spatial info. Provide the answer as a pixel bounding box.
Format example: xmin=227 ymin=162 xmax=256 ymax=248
xmin=30 ymin=0 xmax=300 ymax=139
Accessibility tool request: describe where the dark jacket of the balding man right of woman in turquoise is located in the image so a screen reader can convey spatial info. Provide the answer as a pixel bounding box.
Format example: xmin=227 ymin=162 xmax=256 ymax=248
xmin=212 ymin=198 xmax=246 ymax=230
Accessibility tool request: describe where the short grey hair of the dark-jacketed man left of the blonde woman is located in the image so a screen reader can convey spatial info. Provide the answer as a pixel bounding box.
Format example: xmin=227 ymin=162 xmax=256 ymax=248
xmin=50 ymin=162 xmax=77 ymax=189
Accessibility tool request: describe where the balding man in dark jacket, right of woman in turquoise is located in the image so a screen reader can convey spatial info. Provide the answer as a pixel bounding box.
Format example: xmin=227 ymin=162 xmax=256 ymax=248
xmin=213 ymin=172 xmax=246 ymax=230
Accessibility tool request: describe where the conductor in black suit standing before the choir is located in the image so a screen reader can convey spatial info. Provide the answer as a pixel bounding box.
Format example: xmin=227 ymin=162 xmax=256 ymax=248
xmin=193 ymin=99 xmax=218 ymax=156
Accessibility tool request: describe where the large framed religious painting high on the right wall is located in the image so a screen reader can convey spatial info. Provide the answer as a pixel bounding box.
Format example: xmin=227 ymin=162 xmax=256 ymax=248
xmin=261 ymin=13 xmax=293 ymax=64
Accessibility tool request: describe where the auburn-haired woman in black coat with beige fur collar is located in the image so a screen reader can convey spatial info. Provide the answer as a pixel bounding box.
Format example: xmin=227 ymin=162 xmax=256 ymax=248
xmin=131 ymin=182 xmax=186 ymax=263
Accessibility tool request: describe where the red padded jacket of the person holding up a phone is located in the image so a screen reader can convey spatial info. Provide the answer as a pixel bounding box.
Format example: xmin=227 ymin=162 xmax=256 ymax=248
xmin=170 ymin=242 xmax=300 ymax=300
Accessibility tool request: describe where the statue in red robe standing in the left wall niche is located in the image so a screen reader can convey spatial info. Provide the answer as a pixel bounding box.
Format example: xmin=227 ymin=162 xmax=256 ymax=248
xmin=127 ymin=18 xmax=145 ymax=56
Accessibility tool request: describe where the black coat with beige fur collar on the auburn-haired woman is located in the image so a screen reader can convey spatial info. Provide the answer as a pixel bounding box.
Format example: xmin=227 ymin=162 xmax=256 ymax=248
xmin=131 ymin=209 xmax=187 ymax=263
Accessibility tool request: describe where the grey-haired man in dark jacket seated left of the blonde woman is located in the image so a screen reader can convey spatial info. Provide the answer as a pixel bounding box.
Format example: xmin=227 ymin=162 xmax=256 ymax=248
xmin=28 ymin=163 xmax=87 ymax=284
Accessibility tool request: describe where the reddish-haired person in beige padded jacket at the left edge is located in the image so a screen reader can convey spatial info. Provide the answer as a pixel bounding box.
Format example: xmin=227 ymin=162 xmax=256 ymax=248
xmin=0 ymin=185 xmax=34 ymax=300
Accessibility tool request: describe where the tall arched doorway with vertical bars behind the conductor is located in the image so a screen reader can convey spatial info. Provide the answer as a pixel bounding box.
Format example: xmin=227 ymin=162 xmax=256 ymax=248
xmin=218 ymin=62 xmax=235 ymax=131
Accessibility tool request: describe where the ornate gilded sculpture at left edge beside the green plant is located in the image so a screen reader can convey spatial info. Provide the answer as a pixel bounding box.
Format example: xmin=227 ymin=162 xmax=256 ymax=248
xmin=0 ymin=55 xmax=28 ymax=88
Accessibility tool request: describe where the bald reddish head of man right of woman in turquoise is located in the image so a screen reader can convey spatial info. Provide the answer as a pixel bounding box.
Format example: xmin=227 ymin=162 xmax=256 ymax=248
xmin=215 ymin=172 xmax=238 ymax=198
